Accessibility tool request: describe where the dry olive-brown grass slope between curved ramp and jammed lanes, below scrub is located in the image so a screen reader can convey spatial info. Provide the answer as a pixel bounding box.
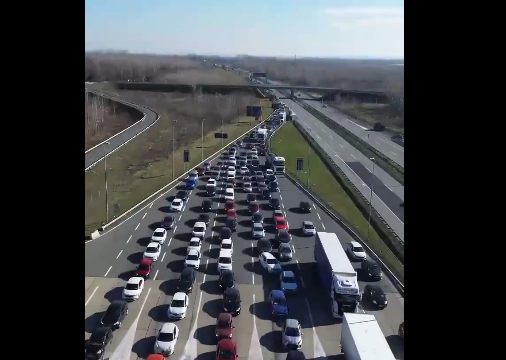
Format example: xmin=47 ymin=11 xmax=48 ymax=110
xmin=85 ymin=100 xmax=272 ymax=238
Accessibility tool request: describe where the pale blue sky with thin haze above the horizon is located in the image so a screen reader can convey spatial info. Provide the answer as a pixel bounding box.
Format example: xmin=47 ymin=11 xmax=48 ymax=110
xmin=85 ymin=0 xmax=404 ymax=58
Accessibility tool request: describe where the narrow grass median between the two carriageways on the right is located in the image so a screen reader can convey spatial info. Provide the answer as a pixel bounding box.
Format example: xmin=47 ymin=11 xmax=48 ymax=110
xmin=301 ymin=103 xmax=404 ymax=186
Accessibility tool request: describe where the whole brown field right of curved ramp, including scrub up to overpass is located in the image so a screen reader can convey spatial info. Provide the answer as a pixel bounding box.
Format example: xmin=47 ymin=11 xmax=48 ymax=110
xmin=85 ymin=91 xmax=272 ymax=235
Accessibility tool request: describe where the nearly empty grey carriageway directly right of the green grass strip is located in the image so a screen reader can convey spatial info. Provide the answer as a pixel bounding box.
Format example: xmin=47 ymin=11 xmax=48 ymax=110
xmin=274 ymin=91 xmax=404 ymax=241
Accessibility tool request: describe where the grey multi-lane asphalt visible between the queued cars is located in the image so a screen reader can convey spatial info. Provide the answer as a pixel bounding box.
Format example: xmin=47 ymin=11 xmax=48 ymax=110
xmin=85 ymin=140 xmax=404 ymax=360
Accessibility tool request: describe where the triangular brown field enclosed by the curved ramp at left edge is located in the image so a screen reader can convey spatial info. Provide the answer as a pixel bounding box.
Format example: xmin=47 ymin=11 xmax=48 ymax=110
xmin=84 ymin=91 xmax=142 ymax=151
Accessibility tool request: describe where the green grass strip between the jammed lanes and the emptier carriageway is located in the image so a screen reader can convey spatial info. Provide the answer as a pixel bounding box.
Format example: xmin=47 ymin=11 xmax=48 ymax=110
xmin=271 ymin=123 xmax=404 ymax=282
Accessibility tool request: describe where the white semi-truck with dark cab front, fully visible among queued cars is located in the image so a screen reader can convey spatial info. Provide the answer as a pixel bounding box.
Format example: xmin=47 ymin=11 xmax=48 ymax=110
xmin=314 ymin=232 xmax=362 ymax=318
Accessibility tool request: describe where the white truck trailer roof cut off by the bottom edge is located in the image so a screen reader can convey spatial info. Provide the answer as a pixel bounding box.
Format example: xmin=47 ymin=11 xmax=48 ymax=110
xmin=341 ymin=313 xmax=395 ymax=360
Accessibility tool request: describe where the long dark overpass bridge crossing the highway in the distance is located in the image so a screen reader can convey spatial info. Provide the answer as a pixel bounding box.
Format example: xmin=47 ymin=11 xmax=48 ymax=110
xmin=113 ymin=82 xmax=389 ymax=103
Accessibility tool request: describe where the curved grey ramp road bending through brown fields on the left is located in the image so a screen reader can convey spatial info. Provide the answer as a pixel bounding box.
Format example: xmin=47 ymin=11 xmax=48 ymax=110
xmin=84 ymin=88 xmax=158 ymax=169
